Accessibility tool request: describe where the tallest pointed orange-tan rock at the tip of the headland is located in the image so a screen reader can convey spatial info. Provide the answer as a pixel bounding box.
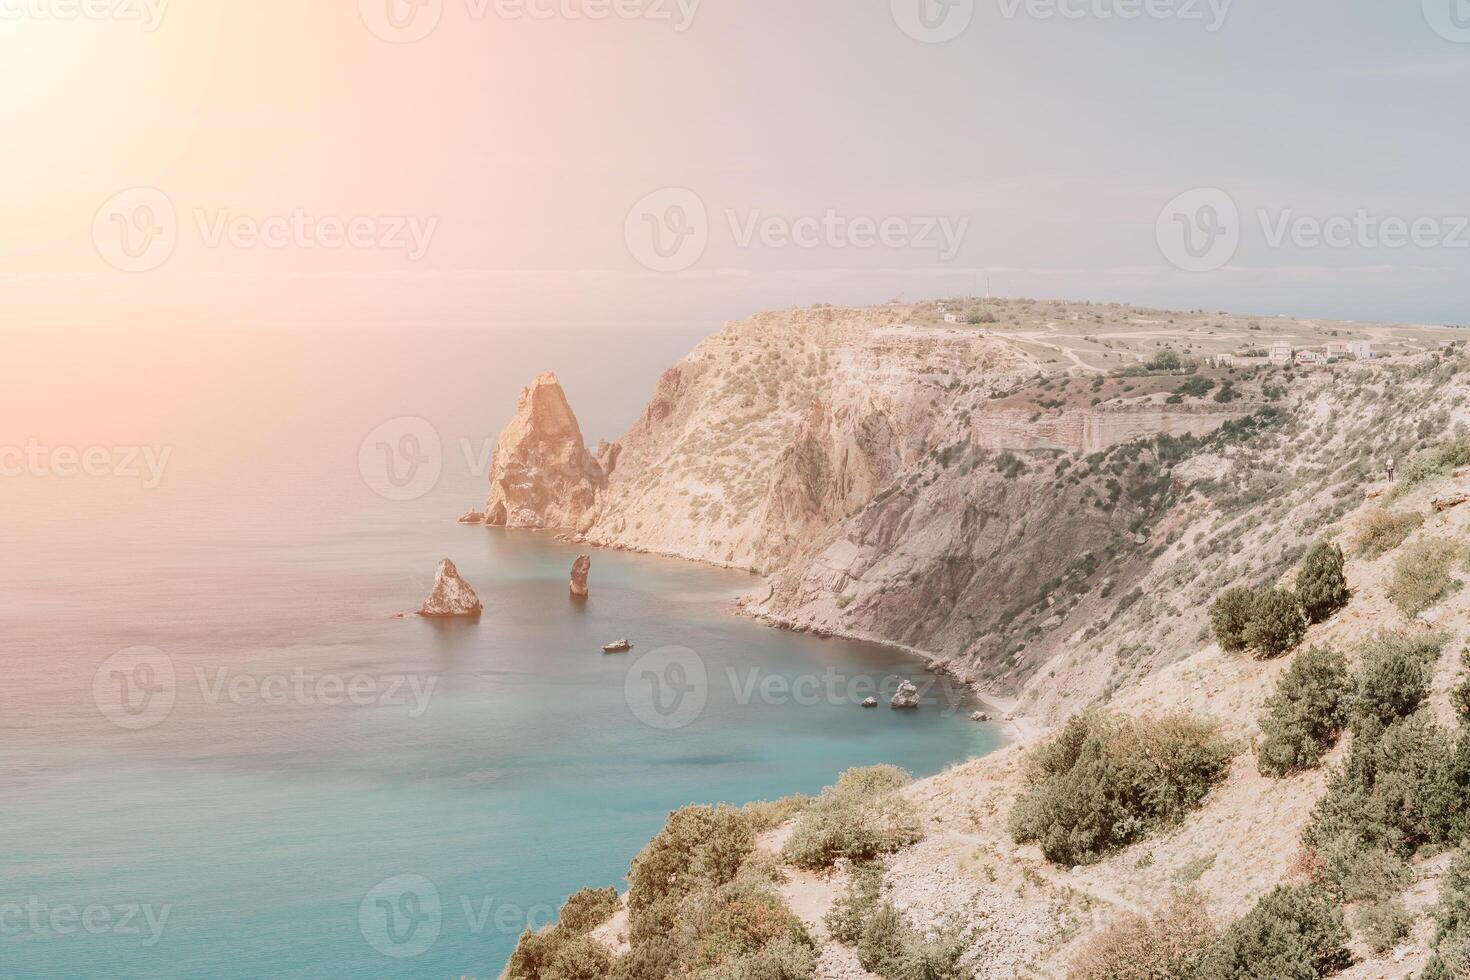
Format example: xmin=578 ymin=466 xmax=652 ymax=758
xmin=485 ymin=373 xmax=607 ymax=529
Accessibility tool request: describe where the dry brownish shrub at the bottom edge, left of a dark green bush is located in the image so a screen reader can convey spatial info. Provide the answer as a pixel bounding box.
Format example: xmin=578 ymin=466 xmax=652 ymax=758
xmin=1067 ymin=892 xmax=1219 ymax=980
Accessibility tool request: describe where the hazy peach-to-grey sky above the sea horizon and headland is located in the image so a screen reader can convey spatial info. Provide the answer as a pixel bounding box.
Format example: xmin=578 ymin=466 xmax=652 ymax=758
xmin=0 ymin=0 xmax=1470 ymax=329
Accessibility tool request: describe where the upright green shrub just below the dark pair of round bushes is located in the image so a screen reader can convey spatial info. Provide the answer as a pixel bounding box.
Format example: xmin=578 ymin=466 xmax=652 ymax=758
xmin=1258 ymin=646 xmax=1352 ymax=777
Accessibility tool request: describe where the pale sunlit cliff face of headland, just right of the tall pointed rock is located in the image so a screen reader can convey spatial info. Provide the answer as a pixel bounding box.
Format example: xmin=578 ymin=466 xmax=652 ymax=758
xmin=573 ymin=307 xmax=1032 ymax=573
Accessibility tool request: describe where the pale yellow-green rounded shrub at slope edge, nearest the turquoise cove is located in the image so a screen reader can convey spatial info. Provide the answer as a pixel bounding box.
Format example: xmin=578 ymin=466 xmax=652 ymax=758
xmin=781 ymin=765 xmax=923 ymax=870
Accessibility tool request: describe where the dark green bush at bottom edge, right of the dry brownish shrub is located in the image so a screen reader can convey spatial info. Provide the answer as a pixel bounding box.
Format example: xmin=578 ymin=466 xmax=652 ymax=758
xmin=1200 ymin=884 xmax=1352 ymax=980
